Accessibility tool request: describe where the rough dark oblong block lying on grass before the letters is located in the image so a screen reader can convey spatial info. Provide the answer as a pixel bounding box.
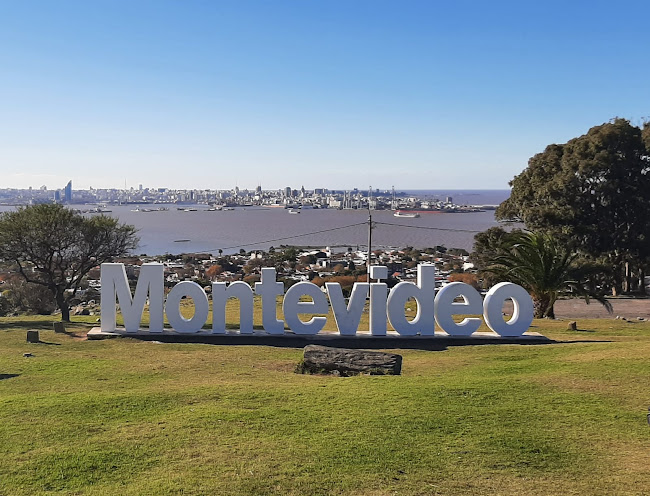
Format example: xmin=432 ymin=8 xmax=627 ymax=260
xmin=302 ymin=344 xmax=402 ymax=376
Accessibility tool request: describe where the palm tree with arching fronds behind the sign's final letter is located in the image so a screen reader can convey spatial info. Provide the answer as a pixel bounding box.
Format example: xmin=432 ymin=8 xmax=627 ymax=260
xmin=486 ymin=231 xmax=612 ymax=319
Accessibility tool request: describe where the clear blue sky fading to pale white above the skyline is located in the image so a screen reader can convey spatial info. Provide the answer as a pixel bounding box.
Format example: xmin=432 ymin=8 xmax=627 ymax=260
xmin=0 ymin=0 xmax=650 ymax=189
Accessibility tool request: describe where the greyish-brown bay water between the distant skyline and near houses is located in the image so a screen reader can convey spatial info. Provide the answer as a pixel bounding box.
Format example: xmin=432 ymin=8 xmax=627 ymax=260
xmin=0 ymin=190 xmax=509 ymax=255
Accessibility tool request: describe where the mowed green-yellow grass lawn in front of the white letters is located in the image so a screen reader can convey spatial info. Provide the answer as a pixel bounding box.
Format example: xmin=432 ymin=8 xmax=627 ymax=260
xmin=0 ymin=300 xmax=650 ymax=495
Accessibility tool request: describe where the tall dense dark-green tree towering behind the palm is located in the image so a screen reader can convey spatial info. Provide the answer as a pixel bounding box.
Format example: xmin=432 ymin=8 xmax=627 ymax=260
xmin=496 ymin=119 xmax=650 ymax=294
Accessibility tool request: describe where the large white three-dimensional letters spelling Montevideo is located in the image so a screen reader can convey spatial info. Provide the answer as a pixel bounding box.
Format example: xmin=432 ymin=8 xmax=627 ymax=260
xmin=101 ymin=263 xmax=533 ymax=337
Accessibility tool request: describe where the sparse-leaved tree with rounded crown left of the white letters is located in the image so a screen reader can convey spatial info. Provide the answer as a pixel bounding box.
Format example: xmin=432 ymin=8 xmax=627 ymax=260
xmin=0 ymin=204 xmax=138 ymax=322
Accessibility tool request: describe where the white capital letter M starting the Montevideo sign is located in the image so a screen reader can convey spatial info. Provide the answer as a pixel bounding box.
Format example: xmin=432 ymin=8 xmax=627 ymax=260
xmin=101 ymin=263 xmax=165 ymax=332
